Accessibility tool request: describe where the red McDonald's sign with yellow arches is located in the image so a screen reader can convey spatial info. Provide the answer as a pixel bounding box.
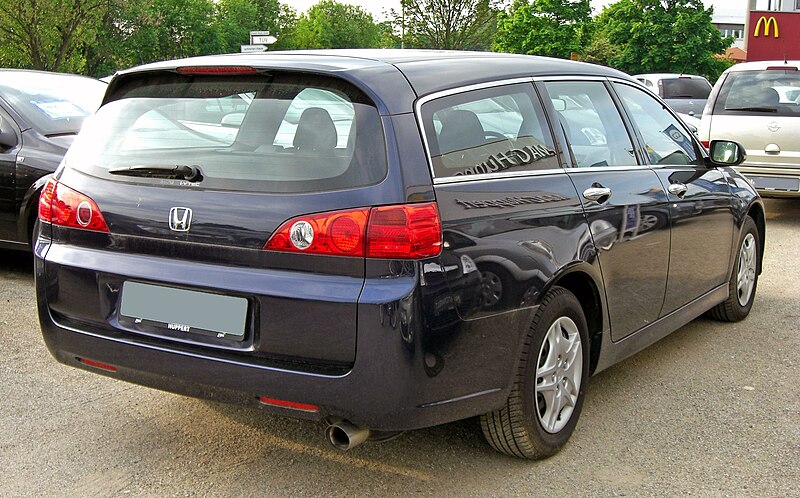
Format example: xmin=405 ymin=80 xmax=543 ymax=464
xmin=747 ymin=11 xmax=800 ymax=61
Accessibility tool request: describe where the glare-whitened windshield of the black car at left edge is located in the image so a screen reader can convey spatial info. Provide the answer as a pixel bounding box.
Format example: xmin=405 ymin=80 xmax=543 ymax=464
xmin=0 ymin=71 xmax=106 ymax=136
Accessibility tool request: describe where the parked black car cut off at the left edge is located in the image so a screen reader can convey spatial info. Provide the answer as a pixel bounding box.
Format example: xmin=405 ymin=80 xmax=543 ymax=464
xmin=0 ymin=69 xmax=106 ymax=250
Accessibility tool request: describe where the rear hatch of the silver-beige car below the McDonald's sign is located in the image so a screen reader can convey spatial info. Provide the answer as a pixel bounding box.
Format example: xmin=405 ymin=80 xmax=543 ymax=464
xmin=709 ymin=66 xmax=800 ymax=191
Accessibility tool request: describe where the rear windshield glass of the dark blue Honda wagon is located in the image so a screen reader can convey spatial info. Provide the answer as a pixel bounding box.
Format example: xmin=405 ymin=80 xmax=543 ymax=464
xmin=65 ymin=73 xmax=386 ymax=193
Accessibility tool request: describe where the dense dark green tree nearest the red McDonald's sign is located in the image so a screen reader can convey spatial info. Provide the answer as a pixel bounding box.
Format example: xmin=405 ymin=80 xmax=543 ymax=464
xmin=596 ymin=0 xmax=732 ymax=81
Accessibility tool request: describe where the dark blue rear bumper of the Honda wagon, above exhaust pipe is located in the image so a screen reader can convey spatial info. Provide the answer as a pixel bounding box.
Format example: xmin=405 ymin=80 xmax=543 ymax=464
xmin=35 ymin=244 xmax=535 ymax=431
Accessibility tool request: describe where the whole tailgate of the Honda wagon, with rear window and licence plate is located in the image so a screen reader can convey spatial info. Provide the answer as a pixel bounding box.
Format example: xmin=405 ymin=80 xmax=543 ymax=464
xmin=39 ymin=68 xmax=402 ymax=371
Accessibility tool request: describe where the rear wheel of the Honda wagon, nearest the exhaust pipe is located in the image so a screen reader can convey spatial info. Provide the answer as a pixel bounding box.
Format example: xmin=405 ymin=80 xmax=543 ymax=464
xmin=481 ymin=287 xmax=589 ymax=460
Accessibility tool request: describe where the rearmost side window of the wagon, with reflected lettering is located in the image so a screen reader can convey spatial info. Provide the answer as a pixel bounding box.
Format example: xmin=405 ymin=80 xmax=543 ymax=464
xmin=421 ymin=84 xmax=560 ymax=178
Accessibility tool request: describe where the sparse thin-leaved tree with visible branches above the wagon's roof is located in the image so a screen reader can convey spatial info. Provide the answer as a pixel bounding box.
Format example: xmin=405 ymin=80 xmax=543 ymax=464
xmin=391 ymin=0 xmax=500 ymax=50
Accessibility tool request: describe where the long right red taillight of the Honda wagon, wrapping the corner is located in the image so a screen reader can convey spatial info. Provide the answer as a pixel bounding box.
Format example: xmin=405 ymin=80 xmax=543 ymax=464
xmin=264 ymin=202 xmax=442 ymax=259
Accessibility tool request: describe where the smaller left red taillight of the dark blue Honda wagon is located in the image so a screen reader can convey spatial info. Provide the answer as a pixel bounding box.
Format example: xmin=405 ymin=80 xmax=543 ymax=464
xmin=39 ymin=178 xmax=108 ymax=232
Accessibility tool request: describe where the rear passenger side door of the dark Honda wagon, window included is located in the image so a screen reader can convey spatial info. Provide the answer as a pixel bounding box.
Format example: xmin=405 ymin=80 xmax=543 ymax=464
xmin=543 ymin=79 xmax=670 ymax=341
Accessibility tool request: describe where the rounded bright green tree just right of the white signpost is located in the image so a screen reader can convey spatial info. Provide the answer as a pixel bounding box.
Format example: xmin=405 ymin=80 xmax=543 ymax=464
xmin=292 ymin=0 xmax=383 ymax=49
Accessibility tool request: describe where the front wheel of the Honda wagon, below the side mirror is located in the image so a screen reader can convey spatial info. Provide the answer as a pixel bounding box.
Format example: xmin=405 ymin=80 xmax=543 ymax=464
xmin=708 ymin=216 xmax=761 ymax=322
